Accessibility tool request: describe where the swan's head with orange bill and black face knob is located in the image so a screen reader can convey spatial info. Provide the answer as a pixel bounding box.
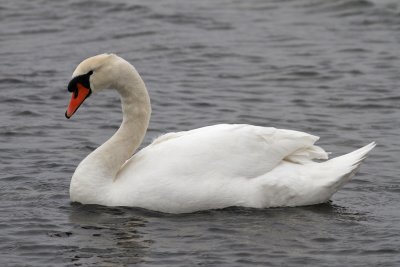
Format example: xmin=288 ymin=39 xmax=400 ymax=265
xmin=65 ymin=54 xmax=125 ymax=119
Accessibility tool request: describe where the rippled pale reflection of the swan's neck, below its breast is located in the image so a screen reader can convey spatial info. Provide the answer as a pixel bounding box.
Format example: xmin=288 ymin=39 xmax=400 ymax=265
xmin=69 ymin=203 xmax=152 ymax=264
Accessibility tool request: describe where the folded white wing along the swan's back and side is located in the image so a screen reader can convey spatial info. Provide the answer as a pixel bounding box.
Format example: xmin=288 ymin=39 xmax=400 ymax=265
xmin=117 ymin=124 xmax=327 ymax=180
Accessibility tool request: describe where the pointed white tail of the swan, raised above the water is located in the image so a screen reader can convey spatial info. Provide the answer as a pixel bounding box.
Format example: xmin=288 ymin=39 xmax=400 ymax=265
xmin=321 ymin=142 xmax=376 ymax=197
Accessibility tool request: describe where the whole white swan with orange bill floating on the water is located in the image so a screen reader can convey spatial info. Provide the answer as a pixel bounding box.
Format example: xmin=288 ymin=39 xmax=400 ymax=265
xmin=65 ymin=54 xmax=375 ymax=213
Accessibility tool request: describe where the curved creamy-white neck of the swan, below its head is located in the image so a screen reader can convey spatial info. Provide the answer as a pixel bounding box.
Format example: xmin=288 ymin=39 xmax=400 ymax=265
xmin=77 ymin=68 xmax=151 ymax=183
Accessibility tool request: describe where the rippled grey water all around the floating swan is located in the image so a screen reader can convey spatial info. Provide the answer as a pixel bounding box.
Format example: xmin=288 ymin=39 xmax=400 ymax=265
xmin=0 ymin=0 xmax=400 ymax=266
